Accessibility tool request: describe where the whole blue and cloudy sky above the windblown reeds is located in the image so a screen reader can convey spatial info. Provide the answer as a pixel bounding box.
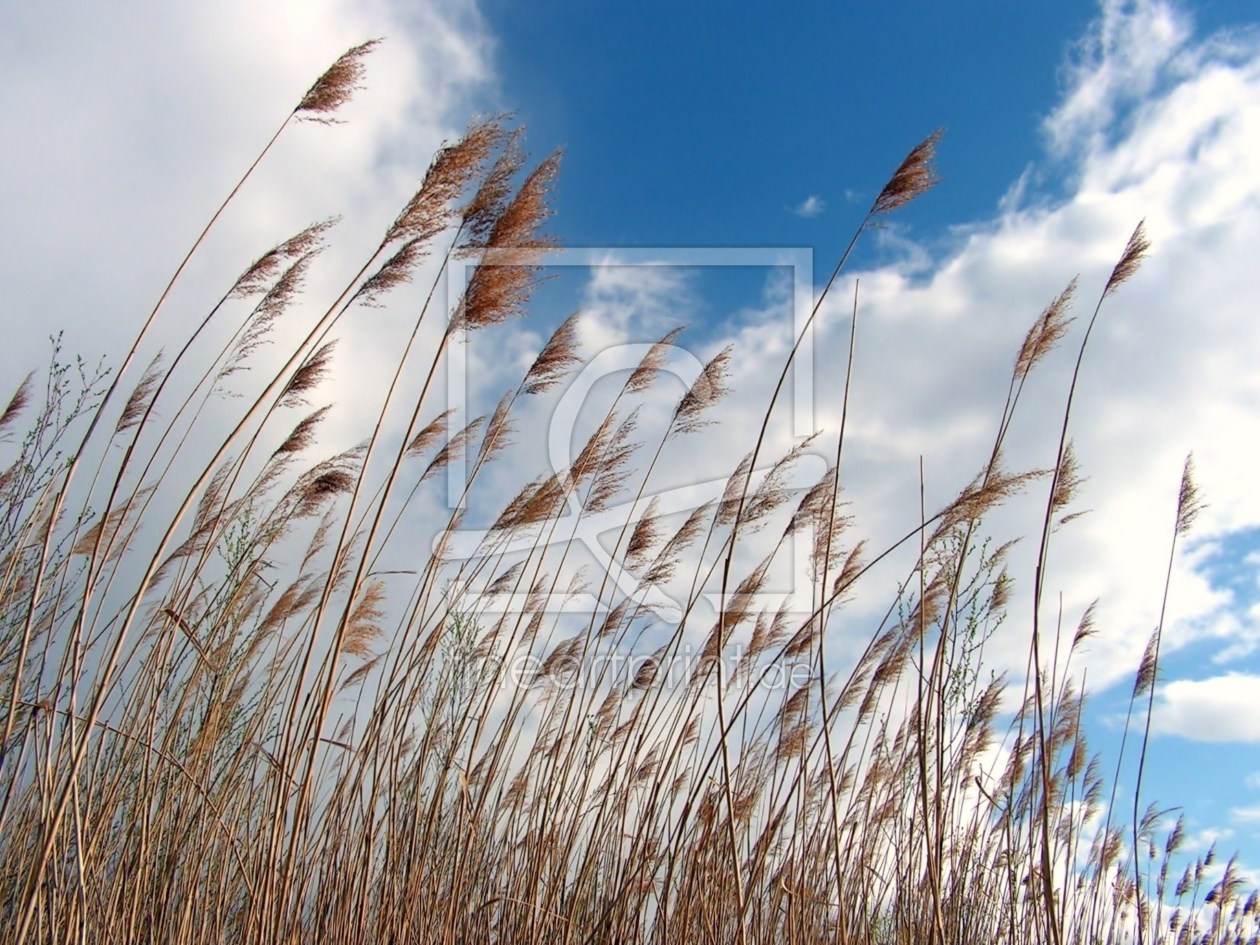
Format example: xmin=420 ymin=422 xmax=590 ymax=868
xmin=0 ymin=0 xmax=1260 ymax=876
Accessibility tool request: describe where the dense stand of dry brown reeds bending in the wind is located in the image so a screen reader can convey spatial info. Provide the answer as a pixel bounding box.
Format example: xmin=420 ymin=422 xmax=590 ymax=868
xmin=0 ymin=43 xmax=1256 ymax=945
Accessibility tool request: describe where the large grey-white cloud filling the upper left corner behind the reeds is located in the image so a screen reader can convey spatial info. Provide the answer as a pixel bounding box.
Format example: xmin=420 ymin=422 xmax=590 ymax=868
xmin=0 ymin=0 xmax=493 ymax=456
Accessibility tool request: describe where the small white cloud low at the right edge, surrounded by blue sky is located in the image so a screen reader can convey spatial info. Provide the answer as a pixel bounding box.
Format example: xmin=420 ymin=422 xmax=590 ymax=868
xmin=1152 ymin=673 xmax=1260 ymax=742
